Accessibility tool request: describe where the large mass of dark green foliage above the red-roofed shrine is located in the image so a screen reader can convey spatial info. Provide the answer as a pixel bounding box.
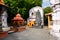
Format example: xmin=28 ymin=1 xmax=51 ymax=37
xmin=4 ymin=0 xmax=42 ymax=19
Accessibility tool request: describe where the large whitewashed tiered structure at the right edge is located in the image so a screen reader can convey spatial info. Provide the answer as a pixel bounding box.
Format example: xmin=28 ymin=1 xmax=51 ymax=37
xmin=50 ymin=0 xmax=60 ymax=37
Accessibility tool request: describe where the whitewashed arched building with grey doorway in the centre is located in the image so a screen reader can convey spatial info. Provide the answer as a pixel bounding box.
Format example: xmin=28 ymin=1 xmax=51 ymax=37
xmin=28 ymin=6 xmax=44 ymax=26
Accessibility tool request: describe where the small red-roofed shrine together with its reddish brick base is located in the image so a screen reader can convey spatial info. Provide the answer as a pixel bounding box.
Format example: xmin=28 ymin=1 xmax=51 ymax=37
xmin=11 ymin=13 xmax=25 ymax=32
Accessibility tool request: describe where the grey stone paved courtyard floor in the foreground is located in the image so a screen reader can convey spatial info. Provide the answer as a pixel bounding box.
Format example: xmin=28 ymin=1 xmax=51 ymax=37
xmin=0 ymin=28 xmax=57 ymax=40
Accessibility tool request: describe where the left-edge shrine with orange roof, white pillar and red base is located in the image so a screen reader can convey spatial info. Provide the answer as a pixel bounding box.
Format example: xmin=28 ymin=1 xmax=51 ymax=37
xmin=0 ymin=0 xmax=10 ymax=38
